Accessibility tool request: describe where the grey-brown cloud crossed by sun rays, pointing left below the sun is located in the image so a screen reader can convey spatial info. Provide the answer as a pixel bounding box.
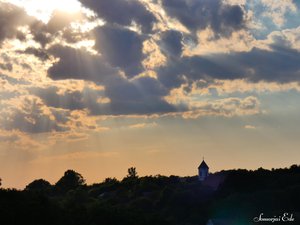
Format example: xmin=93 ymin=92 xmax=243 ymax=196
xmin=48 ymin=45 xmax=118 ymax=83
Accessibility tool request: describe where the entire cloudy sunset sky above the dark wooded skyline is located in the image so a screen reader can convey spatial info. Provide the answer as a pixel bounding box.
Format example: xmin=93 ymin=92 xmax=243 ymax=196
xmin=0 ymin=0 xmax=300 ymax=189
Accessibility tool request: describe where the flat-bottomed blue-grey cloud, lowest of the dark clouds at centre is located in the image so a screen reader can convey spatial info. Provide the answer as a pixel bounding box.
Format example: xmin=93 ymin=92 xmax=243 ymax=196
xmin=101 ymin=77 xmax=176 ymax=115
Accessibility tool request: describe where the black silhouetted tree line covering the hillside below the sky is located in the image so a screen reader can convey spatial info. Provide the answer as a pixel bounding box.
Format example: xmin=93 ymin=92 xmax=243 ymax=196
xmin=0 ymin=165 xmax=300 ymax=225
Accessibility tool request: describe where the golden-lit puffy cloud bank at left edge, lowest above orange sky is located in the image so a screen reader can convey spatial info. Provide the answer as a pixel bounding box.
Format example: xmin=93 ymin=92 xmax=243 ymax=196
xmin=0 ymin=81 xmax=107 ymax=138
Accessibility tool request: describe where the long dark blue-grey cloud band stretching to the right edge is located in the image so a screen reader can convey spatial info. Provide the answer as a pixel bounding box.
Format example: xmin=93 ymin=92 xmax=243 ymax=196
xmin=157 ymin=27 xmax=300 ymax=88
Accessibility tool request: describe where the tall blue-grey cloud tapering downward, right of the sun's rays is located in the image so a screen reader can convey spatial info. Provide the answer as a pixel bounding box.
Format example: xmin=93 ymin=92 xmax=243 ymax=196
xmin=94 ymin=25 xmax=145 ymax=77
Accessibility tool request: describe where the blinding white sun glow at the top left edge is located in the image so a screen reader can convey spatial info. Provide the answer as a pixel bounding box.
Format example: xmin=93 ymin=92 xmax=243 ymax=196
xmin=9 ymin=0 xmax=81 ymax=23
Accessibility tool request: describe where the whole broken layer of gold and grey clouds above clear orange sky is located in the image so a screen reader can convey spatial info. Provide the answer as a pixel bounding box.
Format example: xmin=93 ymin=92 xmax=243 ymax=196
xmin=0 ymin=0 xmax=300 ymax=138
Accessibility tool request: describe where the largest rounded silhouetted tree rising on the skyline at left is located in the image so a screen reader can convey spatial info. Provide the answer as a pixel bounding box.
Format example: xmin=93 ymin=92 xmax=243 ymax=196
xmin=55 ymin=170 xmax=85 ymax=192
